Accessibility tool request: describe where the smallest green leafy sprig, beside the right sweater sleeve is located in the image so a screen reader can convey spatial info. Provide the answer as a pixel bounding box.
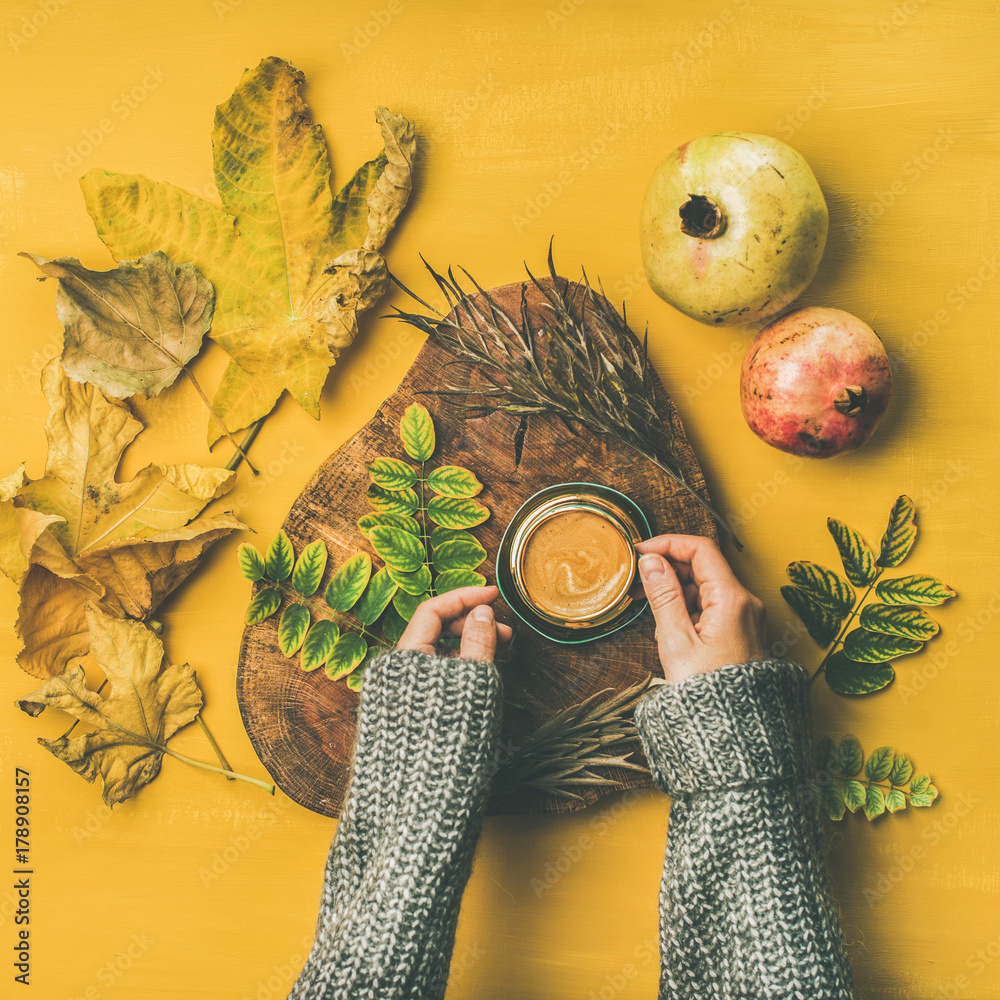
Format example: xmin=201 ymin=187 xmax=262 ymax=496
xmin=814 ymin=734 xmax=938 ymax=820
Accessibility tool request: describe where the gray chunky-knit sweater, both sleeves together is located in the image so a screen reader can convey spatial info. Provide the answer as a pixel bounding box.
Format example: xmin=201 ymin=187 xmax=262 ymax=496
xmin=289 ymin=650 xmax=852 ymax=1000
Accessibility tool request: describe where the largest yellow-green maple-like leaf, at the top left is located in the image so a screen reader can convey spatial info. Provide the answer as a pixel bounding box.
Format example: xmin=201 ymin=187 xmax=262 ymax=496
xmin=80 ymin=57 xmax=416 ymax=444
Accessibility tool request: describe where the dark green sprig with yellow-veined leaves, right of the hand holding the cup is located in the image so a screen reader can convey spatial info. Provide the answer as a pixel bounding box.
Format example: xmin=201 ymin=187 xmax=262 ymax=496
xmin=781 ymin=496 xmax=956 ymax=695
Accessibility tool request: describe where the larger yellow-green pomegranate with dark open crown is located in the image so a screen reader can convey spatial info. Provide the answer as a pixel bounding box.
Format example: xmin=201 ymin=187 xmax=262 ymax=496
xmin=641 ymin=132 xmax=829 ymax=326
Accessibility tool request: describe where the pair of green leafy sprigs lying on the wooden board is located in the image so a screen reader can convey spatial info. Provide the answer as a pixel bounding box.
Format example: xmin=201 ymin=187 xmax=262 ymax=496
xmin=239 ymin=404 xmax=490 ymax=690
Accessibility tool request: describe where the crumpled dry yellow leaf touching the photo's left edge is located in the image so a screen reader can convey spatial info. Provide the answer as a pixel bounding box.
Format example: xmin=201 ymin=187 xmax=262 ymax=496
xmin=0 ymin=362 xmax=244 ymax=677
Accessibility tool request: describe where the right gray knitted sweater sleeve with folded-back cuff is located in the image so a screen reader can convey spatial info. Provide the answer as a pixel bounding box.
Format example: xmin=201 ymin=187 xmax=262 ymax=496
xmin=635 ymin=660 xmax=852 ymax=1000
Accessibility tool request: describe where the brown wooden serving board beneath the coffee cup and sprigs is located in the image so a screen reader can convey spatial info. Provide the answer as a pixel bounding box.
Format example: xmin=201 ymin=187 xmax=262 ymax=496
xmin=236 ymin=279 xmax=716 ymax=816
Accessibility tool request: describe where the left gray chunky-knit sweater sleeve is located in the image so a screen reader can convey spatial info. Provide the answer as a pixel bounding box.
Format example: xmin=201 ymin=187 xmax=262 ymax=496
xmin=289 ymin=650 xmax=501 ymax=1000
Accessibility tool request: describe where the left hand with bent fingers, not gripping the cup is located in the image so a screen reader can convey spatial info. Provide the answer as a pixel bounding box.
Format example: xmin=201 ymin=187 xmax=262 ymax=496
xmin=398 ymin=587 xmax=514 ymax=660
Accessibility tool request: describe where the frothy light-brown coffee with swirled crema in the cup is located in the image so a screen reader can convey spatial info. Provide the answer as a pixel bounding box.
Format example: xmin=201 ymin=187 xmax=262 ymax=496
xmin=521 ymin=510 xmax=633 ymax=619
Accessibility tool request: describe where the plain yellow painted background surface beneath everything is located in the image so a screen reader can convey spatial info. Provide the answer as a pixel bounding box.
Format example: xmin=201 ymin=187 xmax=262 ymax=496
xmin=0 ymin=0 xmax=1000 ymax=1000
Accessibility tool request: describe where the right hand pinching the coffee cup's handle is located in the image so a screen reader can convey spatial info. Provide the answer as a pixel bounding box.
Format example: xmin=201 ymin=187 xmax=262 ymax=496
xmin=635 ymin=535 xmax=765 ymax=681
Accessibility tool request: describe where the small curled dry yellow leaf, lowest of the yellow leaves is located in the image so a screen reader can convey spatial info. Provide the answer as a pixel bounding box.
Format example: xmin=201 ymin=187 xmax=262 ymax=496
xmin=17 ymin=605 xmax=202 ymax=806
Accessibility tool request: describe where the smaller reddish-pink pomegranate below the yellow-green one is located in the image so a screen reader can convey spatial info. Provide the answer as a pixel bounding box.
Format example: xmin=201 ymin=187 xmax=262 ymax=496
xmin=740 ymin=306 xmax=892 ymax=458
